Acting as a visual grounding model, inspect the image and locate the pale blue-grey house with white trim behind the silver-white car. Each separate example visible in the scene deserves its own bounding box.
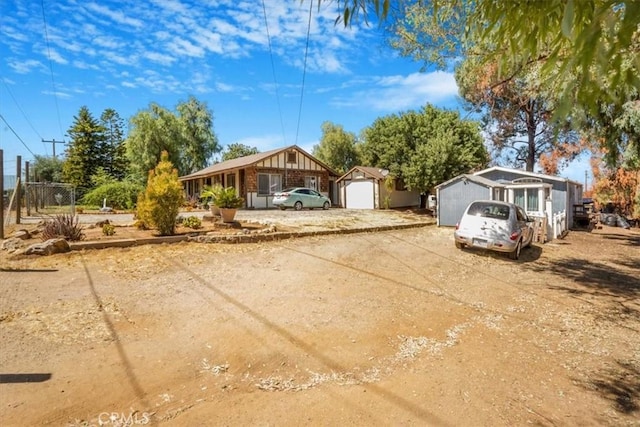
[436,166,582,240]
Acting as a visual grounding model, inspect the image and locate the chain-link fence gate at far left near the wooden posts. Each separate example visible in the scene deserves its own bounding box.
[24,182,76,216]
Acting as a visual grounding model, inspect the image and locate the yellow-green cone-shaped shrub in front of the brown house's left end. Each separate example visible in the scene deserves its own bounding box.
[136,151,184,236]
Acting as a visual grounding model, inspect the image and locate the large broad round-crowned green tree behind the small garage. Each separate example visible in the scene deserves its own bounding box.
[362,105,488,194]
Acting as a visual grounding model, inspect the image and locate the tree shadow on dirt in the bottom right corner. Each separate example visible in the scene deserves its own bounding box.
[578,360,640,415]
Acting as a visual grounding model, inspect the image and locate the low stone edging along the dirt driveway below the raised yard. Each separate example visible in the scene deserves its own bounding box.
[69,222,435,251]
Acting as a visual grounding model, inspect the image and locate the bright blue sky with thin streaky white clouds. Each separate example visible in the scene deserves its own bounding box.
[0,0,585,182]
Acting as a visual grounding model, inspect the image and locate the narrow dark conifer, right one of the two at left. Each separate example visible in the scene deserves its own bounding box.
[100,108,129,181]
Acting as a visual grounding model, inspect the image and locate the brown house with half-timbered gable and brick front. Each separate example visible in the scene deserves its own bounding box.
[179,145,338,209]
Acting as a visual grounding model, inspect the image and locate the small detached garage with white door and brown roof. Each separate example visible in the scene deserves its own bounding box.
[337,166,420,209]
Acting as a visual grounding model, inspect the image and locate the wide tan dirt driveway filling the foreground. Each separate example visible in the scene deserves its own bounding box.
[0,216,640,426]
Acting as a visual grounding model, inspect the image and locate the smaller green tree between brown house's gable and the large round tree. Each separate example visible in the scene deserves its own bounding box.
[312,121,360,173]
